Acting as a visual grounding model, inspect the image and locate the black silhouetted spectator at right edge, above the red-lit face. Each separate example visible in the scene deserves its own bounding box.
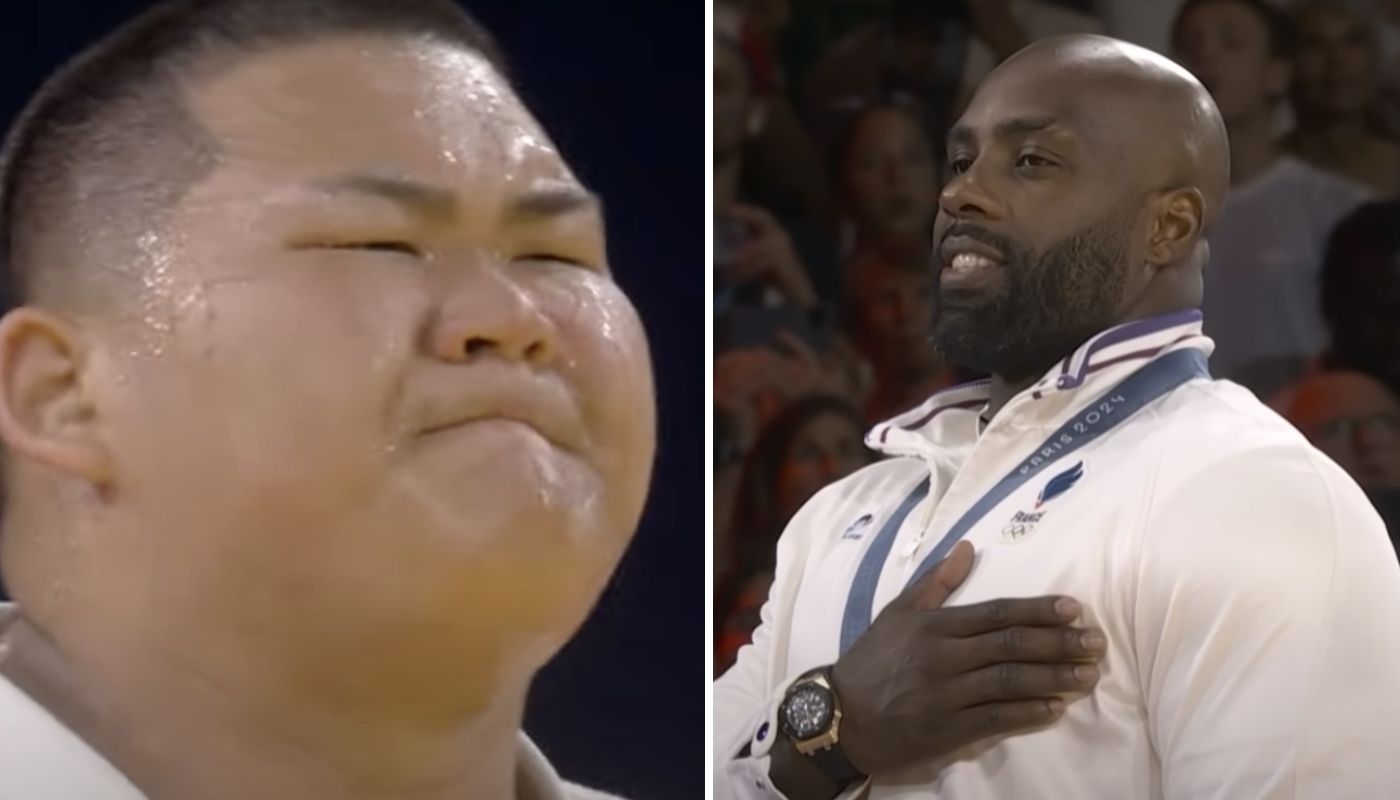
[1322,200,1400,396]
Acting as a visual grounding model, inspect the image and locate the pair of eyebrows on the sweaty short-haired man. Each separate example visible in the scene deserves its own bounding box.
[314,172,602,223]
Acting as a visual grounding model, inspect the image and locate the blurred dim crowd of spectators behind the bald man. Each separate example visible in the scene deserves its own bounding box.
[713,0,1400,674]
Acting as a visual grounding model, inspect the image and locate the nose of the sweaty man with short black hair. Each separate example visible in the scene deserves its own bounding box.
[428,268,557,366]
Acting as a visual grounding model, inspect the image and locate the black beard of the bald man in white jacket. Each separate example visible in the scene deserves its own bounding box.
[932,210,1131,382]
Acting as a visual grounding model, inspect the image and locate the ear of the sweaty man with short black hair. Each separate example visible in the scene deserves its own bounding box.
[0,308,112,486]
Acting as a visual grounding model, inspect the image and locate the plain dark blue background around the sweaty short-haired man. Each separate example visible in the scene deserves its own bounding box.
[0,0,708,800]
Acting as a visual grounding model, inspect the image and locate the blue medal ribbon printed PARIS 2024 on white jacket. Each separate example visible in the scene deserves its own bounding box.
[840,347,1210,654]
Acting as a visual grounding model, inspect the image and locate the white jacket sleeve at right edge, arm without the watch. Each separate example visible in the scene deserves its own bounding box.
[1131,444,1400,800]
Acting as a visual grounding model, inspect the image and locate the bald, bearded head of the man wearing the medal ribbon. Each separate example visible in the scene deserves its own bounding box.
[934,36,1229,381]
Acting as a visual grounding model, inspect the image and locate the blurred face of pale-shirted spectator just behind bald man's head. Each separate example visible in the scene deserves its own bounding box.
[1173,0,1289,125]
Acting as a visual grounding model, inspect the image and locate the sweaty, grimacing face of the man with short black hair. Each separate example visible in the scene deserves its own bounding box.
[80,38,655,683]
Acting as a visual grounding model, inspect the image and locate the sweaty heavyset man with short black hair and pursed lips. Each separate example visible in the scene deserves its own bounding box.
[0,0,652,800]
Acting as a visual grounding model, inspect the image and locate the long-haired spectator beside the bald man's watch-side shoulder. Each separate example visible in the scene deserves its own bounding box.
[714,395,872,674]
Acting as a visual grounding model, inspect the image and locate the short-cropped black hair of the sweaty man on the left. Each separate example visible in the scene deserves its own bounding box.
[0,0,508,318]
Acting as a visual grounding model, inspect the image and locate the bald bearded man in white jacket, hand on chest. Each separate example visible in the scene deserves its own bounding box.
[714,36,1400,800]
